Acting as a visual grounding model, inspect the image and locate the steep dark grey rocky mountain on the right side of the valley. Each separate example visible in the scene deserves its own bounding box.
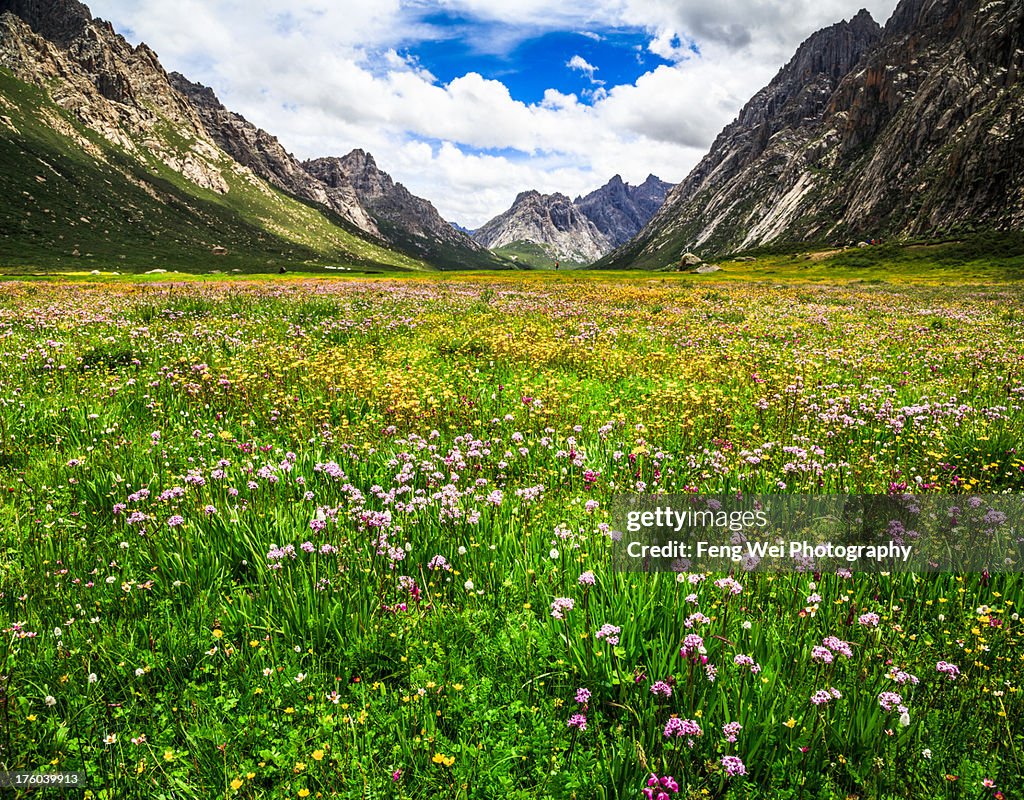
[597,0,1024,267]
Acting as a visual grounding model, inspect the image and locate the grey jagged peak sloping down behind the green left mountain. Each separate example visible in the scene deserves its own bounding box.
[302,150,508,269]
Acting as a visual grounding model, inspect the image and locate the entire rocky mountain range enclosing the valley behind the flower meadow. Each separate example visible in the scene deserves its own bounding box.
[0,0,1024,271]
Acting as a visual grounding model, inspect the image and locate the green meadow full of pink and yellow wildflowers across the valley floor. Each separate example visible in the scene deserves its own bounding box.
[0,275,1024,800]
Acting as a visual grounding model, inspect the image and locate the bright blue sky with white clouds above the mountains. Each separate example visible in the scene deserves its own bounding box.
[89,0,896,227]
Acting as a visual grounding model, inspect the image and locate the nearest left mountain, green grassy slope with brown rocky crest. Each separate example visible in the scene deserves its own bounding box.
[0,0,428,271]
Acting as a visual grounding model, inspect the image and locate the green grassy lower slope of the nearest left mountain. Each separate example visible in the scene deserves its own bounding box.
[0,69,428,272]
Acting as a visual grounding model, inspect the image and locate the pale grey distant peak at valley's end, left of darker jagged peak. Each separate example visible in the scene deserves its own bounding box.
[473,192,611,265]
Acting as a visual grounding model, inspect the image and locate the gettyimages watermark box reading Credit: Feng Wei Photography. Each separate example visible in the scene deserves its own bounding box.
[611,495,1024,573]
